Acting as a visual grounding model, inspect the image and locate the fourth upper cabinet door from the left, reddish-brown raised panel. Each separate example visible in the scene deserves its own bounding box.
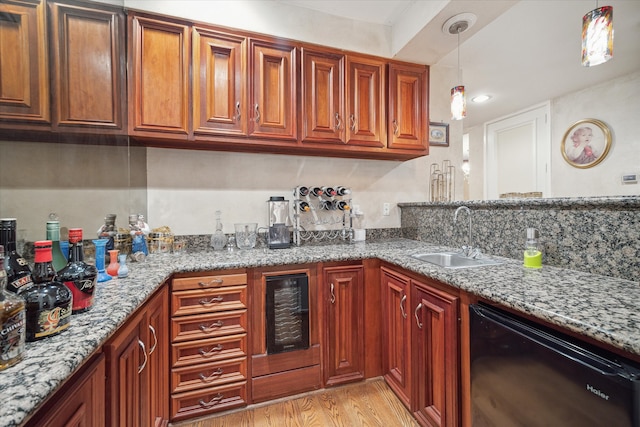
[193,27,248,136]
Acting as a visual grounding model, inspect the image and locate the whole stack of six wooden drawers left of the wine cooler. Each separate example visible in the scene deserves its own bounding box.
[167,270,250,421]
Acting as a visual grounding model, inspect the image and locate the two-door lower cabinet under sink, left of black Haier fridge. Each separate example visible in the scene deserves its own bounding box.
[381,267,460,427]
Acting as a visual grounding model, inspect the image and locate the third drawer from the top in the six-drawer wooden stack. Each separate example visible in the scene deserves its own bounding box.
[171,310,247,342]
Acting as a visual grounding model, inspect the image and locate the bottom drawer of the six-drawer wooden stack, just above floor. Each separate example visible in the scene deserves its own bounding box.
[171,381,247,421]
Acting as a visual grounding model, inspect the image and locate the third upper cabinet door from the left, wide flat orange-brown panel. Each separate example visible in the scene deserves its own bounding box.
[129,14,191,140]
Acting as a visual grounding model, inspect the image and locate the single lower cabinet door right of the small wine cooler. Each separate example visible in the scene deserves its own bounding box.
[323,266,365,386]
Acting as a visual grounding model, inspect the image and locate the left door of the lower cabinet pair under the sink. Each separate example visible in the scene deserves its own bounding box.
[381,267,411,408]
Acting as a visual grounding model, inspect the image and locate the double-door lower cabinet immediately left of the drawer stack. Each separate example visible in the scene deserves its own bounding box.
[104,286,169,427]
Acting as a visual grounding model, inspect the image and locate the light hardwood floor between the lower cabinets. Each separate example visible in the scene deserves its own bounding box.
[172,378,418,427]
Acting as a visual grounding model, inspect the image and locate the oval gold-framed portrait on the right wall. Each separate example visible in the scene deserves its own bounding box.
[560,119,611,169]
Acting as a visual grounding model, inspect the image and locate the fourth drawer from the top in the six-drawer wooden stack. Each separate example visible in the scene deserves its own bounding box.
[171,334,247,368]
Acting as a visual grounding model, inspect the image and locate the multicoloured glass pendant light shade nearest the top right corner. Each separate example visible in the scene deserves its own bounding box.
[582,2,613,67]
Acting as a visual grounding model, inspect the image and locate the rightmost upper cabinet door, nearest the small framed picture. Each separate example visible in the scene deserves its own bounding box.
[388,63,429,150]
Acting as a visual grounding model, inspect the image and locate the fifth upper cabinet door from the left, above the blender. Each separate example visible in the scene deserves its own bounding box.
[249,39,298,141]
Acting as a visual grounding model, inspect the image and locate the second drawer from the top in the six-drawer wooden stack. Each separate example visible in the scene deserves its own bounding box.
[171,285,247,316]
